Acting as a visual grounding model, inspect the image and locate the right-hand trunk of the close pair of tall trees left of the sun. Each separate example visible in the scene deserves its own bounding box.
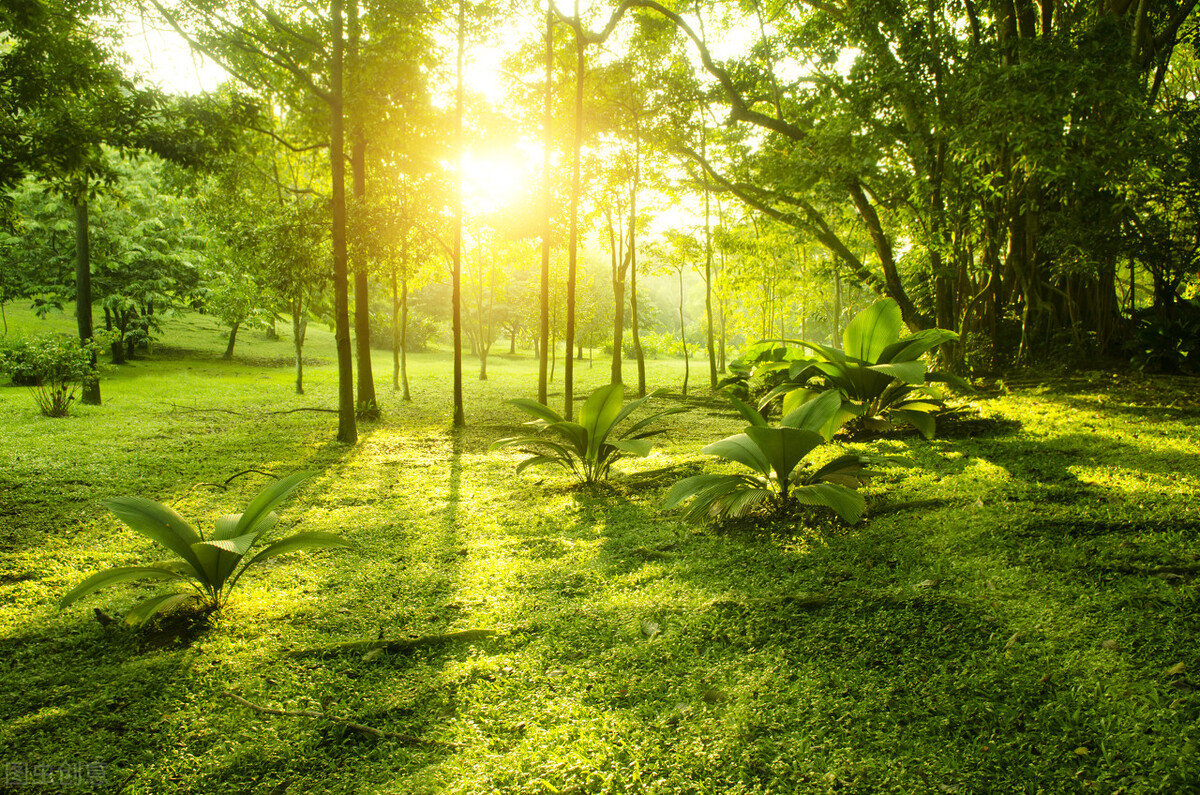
[346,0,379,417]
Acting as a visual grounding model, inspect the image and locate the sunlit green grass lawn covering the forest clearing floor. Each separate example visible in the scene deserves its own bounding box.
[0,310,1200,794]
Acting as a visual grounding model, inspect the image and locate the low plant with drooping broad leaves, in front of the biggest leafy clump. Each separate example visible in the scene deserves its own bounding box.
[664,391,893,524]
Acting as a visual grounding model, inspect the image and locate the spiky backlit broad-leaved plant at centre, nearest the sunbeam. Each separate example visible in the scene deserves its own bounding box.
[491,384,686,483]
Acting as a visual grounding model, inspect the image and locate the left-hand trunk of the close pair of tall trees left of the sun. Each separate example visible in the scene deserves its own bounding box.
[329,0,359,444]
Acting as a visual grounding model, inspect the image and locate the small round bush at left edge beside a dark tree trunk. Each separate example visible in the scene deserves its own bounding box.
[0,334,102,417]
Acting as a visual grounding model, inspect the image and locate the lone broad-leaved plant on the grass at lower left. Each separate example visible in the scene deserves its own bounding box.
[59,472,353,624]
